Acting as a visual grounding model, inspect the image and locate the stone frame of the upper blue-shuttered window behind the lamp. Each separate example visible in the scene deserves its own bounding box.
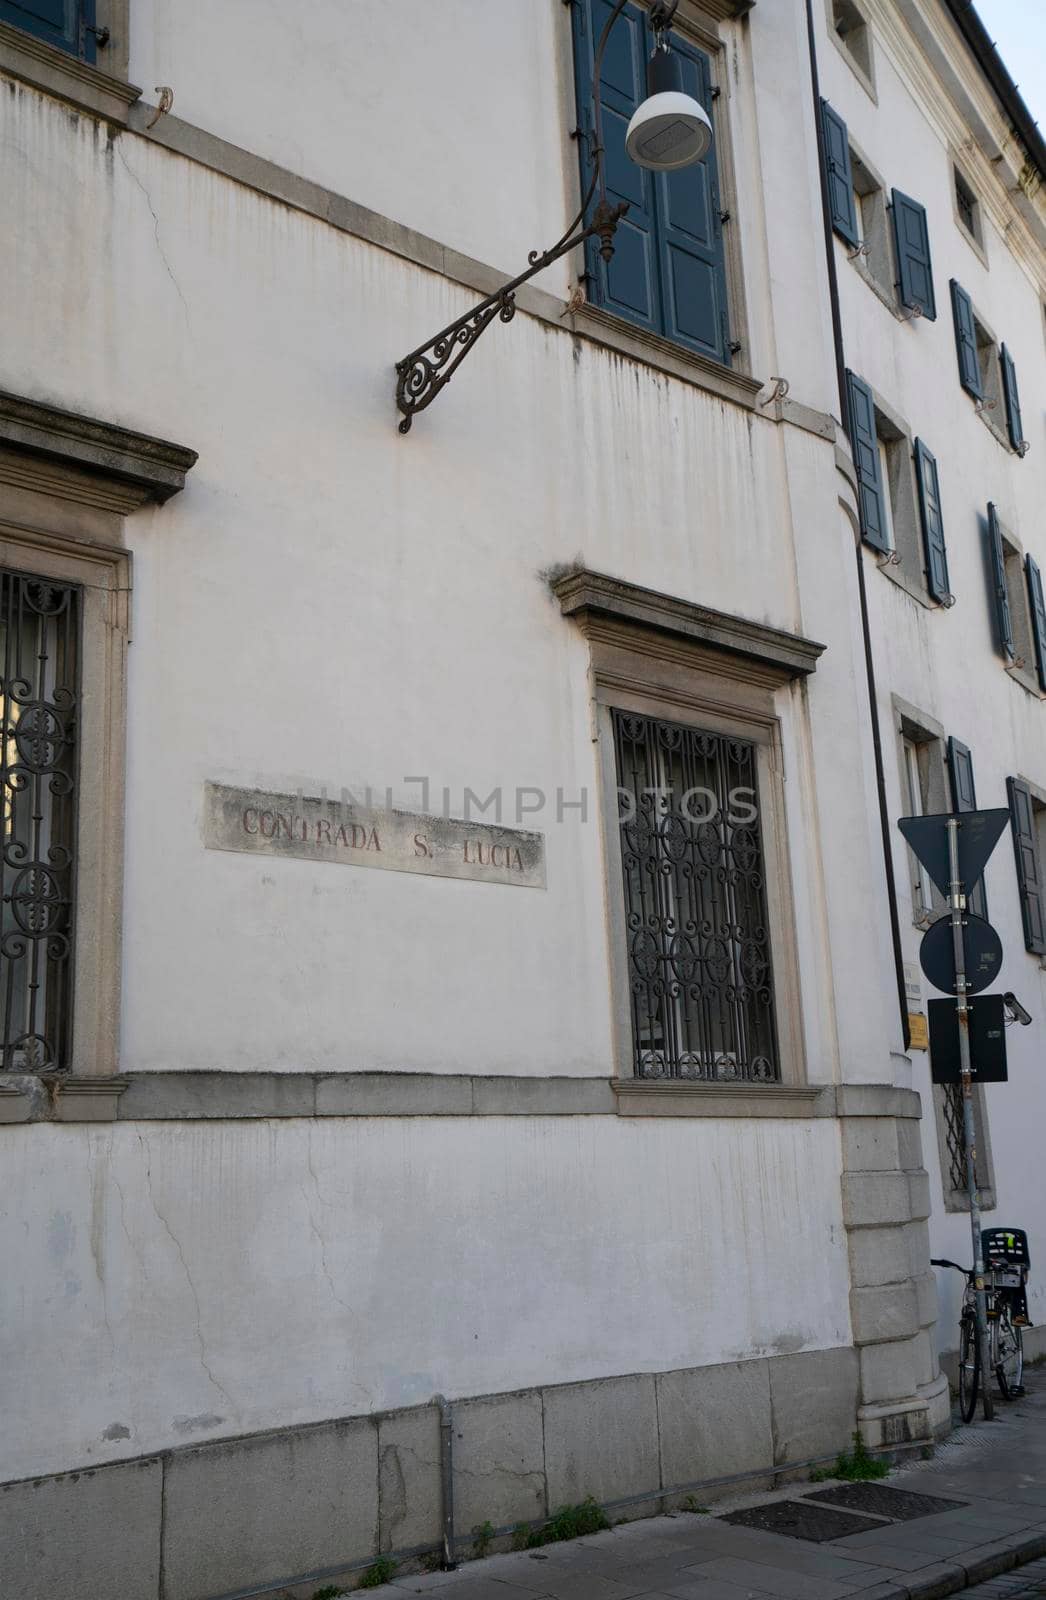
[566,0,761,396]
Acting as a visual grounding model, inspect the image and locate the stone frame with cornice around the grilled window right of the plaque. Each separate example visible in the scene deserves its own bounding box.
[552,568,824,1117]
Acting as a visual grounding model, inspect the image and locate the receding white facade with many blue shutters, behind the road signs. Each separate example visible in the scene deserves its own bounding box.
[819,0,1046,1376]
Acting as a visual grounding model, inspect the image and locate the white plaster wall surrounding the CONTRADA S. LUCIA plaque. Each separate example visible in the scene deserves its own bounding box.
[3,91,884,1080]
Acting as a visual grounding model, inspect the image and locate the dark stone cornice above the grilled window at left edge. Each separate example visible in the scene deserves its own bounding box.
[0,390,197,512]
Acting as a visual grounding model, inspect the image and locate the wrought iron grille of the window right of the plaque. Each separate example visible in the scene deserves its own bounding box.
[614,710,781,1083]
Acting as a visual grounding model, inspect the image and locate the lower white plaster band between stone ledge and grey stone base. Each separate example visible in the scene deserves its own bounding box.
[0,1117,849,1478]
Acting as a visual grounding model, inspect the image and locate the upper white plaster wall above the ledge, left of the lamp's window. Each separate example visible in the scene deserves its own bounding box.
[130,0,579,291]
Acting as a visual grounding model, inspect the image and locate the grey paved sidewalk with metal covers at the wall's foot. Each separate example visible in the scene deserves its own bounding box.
[373,1368,1046,1600]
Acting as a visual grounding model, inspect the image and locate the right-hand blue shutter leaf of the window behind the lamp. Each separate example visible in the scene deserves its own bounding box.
[651,34,729,362]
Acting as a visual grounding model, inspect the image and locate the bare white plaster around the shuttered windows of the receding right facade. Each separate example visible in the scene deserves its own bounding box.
[814,6,1046,1324]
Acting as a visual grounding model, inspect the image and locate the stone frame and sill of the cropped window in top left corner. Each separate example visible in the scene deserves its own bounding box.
[0,0,142,126]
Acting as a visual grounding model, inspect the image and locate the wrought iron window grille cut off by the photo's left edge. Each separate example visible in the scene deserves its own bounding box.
[0,571,80,1072]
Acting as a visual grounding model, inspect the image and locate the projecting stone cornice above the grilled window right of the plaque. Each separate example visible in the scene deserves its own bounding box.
[552,568,825,683]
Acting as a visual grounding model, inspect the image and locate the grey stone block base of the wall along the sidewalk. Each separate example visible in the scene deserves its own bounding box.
[0,1347,859,1600]
